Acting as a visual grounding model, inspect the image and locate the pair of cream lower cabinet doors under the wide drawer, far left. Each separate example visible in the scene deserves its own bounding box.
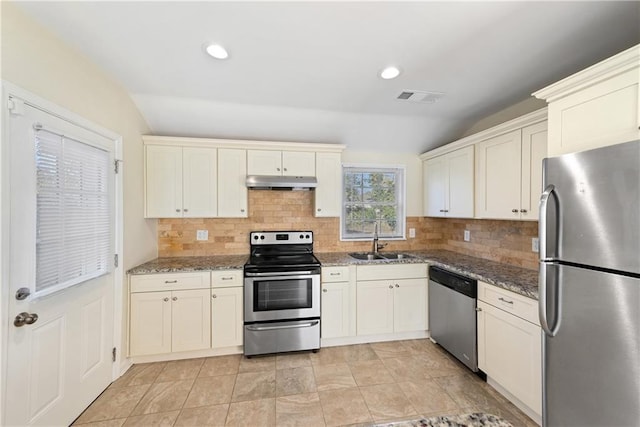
[130,289,211,356]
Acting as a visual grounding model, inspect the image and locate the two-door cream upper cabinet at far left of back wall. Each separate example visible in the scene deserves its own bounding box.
[145,145,218,218]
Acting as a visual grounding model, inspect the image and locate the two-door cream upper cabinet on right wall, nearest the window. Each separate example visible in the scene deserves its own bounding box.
[423,146,474,218]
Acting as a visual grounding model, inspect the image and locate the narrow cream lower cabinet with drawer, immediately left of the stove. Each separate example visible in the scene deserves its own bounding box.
[211,270,244,348]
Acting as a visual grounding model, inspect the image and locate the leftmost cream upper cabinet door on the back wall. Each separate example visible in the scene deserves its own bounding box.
[144,145,182,218]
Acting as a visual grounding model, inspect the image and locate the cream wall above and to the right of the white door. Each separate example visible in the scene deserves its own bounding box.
[1,1,157,374]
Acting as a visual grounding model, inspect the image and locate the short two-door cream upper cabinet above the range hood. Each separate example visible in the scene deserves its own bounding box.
[247,150,316,176]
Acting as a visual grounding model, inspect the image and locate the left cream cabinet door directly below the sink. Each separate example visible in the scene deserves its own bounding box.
[356,280,393,335]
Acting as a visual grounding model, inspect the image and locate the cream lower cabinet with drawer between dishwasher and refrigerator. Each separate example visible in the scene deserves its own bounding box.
[478,282,542,419]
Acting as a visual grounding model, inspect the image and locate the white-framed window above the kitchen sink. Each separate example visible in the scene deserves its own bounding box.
[341,165,405,240]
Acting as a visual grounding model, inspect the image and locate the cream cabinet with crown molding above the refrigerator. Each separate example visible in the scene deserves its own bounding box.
[534,45,640,156]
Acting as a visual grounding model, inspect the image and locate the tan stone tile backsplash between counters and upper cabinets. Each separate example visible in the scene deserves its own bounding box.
[158,190,538,269]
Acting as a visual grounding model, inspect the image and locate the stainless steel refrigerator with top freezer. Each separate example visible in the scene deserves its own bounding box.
[539,141,640,427]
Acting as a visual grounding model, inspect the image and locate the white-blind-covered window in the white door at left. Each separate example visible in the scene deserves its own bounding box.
[35,128,114,295]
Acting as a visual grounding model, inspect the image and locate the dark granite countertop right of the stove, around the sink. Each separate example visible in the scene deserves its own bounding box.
[315,250,538,299]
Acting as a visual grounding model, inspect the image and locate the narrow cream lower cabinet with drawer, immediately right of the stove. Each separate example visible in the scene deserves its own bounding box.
[320,266,356,338]
